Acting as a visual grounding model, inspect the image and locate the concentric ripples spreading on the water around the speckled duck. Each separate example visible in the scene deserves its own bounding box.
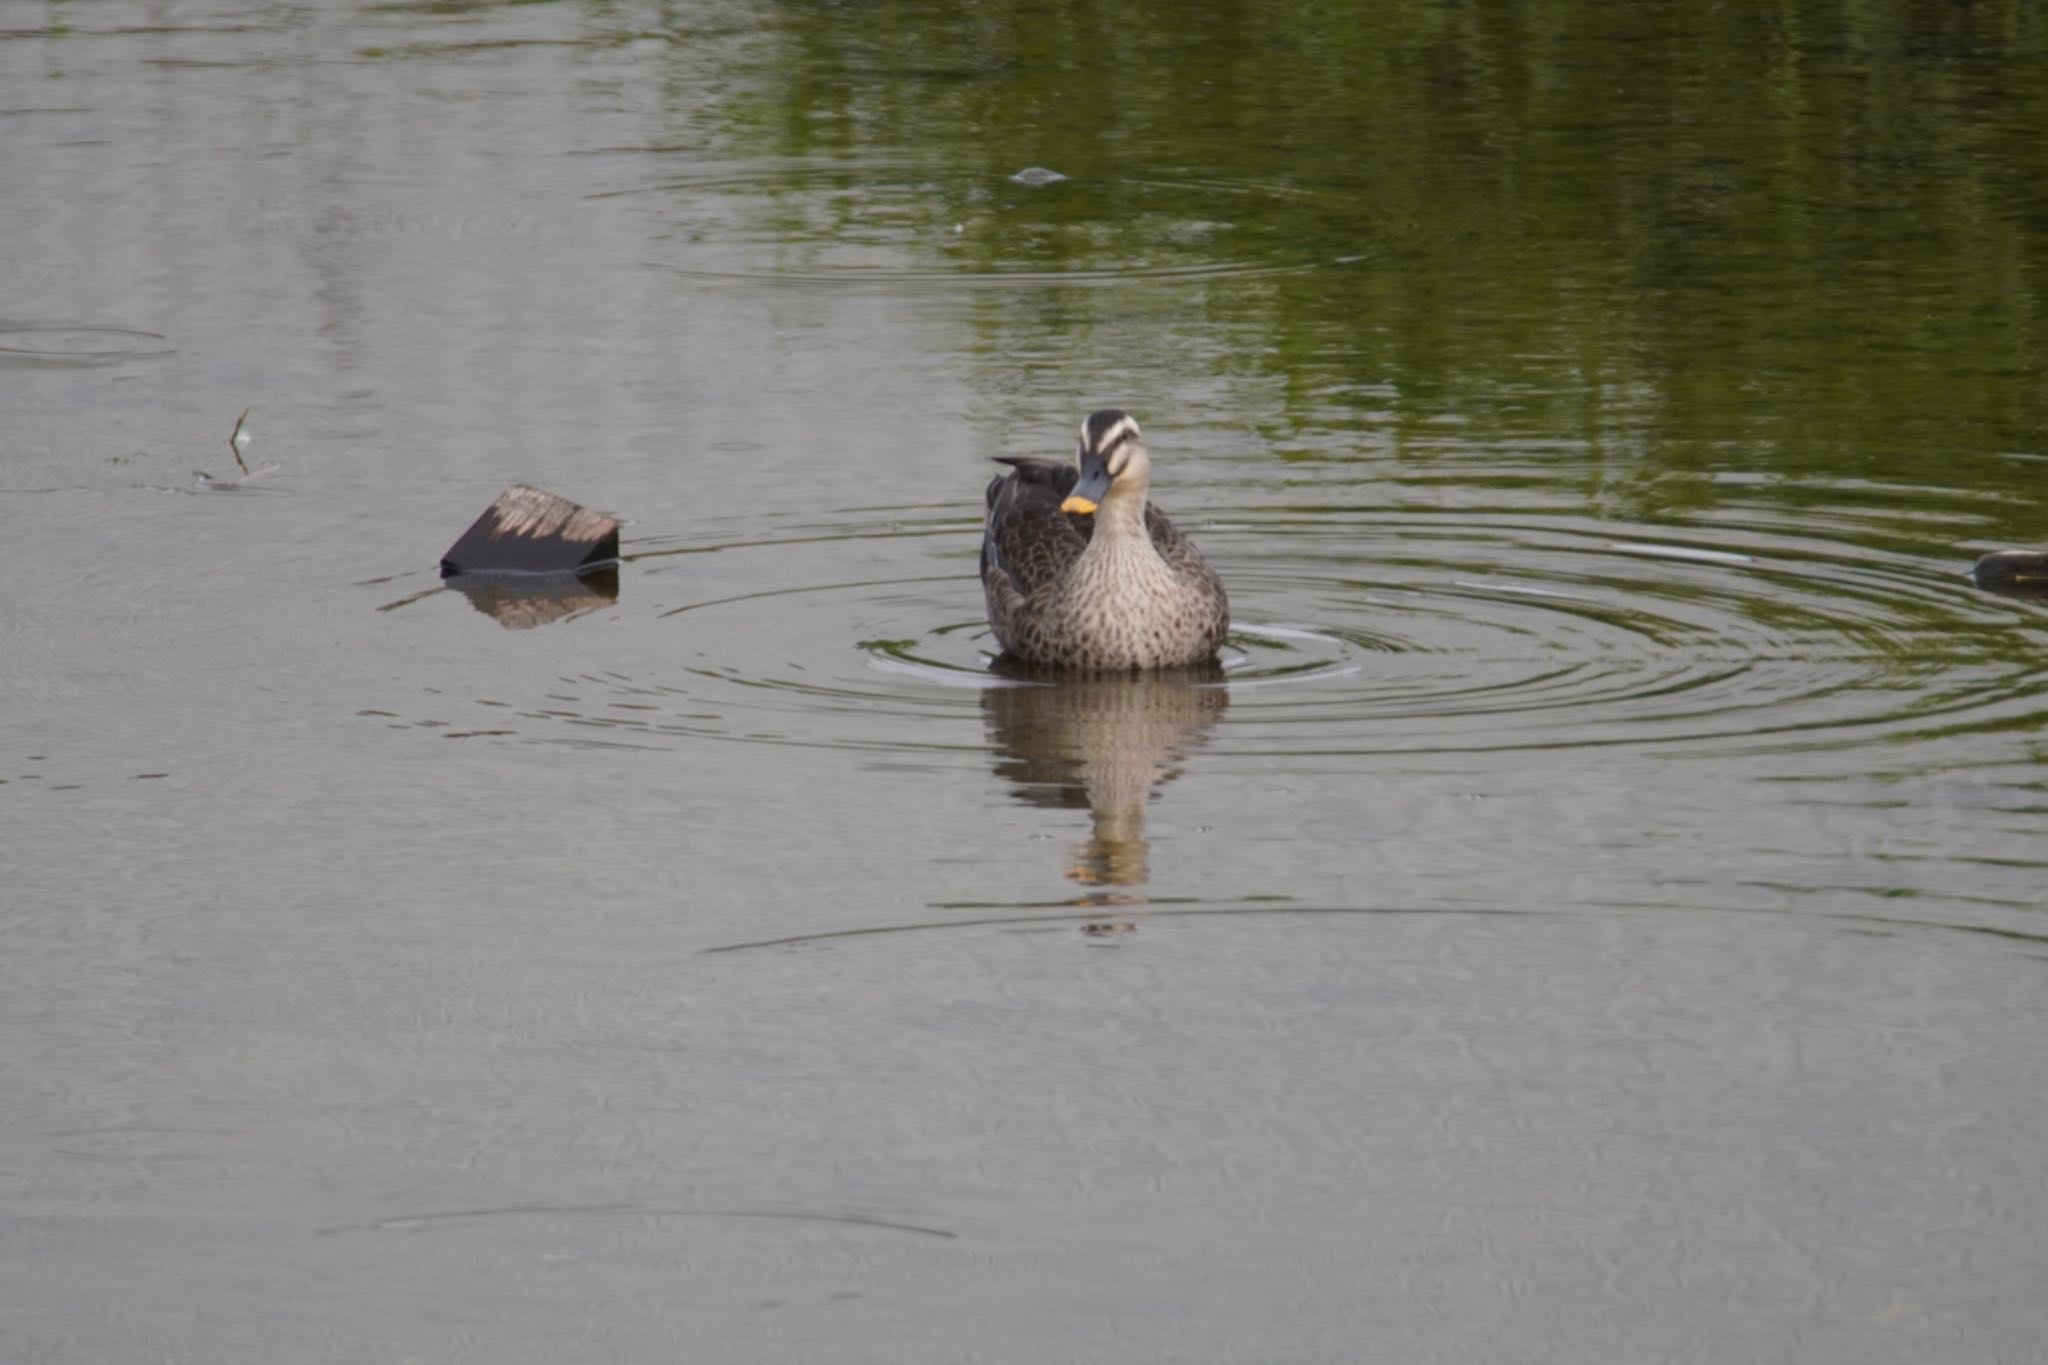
[376,512,2048,763]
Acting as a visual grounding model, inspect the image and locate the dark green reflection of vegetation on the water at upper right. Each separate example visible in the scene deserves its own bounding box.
[692,0,2048,509]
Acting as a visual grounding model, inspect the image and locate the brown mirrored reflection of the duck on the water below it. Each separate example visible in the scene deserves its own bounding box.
[981,665,1231,905]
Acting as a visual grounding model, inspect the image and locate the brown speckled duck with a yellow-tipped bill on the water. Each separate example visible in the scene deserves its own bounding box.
[981,407,1231,673]
